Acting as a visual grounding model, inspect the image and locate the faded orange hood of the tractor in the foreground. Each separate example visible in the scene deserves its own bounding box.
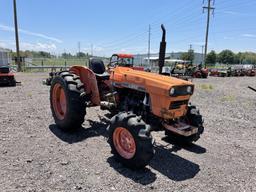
[110,67,194,95]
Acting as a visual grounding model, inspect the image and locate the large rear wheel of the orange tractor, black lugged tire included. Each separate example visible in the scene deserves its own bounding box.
[50,72,86,131]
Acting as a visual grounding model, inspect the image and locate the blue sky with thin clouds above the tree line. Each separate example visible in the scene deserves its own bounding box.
[0,0,256,56]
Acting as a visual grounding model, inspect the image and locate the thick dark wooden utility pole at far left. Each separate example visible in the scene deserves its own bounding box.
[13,0,21,72]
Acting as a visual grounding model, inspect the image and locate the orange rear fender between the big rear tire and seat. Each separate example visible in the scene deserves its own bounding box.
[69,66,100,105]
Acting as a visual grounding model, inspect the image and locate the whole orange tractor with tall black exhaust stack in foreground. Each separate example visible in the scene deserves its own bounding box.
[50,26,204,169]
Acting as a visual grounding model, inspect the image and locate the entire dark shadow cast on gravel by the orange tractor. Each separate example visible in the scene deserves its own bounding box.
[49,121,202,185]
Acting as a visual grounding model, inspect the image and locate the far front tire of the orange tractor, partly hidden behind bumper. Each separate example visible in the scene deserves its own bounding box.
[165,106,204,144]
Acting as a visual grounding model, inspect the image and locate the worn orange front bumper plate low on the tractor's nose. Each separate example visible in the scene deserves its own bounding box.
[163,123,198,137]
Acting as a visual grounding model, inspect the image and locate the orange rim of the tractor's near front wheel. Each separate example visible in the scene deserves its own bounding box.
[113,127,136,159]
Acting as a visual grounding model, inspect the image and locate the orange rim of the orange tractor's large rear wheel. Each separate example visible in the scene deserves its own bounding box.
[52,83,67,120]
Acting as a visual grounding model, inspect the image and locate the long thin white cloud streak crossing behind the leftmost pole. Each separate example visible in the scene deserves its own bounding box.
[0,24,62,43]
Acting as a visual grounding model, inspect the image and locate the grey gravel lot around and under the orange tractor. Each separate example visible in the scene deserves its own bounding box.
[0,73,256,192]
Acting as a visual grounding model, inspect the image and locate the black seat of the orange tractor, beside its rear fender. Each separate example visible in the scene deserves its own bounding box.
[89,58,110,80]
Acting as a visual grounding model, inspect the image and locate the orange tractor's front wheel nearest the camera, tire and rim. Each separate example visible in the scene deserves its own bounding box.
[108,112,155,169]
